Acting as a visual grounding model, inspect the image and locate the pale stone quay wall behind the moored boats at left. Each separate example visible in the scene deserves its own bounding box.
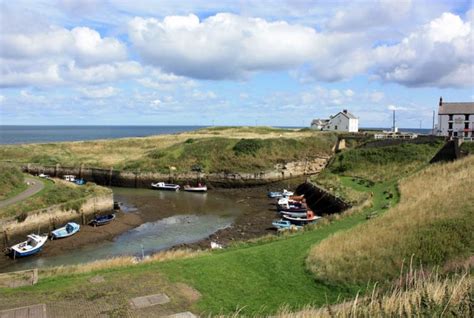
[0,191,114,244]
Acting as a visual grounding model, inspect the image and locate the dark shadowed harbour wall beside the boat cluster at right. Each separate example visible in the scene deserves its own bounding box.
[296,182,351,215]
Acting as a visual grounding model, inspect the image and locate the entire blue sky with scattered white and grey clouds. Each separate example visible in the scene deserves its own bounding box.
[0,0,474,128]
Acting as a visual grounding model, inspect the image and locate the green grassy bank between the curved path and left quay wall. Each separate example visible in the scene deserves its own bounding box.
[0,179,111,222]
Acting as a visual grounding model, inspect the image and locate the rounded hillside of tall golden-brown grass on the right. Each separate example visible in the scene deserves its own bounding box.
[307,156,474,284]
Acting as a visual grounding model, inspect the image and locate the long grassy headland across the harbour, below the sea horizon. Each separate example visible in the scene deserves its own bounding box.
[0,127,336,173]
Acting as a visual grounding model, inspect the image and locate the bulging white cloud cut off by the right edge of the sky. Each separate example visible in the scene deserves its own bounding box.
[374,13,474,87]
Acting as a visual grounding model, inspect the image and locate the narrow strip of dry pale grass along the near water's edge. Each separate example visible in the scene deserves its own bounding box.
[39,249,208,278]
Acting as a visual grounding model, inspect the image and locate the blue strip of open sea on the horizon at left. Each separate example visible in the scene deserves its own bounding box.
[0,125,204,144]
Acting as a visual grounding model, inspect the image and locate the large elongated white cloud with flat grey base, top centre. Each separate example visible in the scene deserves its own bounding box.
[129,13,317,79]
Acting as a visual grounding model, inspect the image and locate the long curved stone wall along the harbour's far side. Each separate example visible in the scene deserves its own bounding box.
[21,156,330,188]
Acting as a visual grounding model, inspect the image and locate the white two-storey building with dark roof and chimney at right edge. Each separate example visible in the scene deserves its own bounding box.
[436,97,474,140]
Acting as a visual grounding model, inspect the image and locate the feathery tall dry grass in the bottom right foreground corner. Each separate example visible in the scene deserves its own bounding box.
[277,271,474,318]
